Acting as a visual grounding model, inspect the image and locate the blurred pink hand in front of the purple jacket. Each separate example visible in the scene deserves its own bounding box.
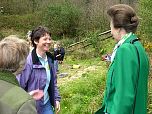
[29,89,44,100]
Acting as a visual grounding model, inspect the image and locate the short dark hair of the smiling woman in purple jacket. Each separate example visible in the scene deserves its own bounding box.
[30,26,51,48]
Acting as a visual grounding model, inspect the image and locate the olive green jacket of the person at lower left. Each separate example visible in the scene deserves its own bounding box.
[0,71,37,114]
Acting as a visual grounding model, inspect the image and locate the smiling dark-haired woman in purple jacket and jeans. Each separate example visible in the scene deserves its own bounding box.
[17,27,61,114]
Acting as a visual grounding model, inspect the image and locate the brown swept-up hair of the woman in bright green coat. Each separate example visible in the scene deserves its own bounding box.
[107,4,139,33]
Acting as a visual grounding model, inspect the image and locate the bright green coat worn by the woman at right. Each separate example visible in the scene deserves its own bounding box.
[95,35,149,114]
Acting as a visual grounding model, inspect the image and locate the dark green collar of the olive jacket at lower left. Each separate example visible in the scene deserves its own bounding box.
[0,71,19,86]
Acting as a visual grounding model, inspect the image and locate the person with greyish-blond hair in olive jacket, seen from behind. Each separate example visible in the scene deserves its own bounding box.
[0,35,37,114]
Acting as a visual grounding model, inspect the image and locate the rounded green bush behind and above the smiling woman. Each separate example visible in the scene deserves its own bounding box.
[43,2,81,36]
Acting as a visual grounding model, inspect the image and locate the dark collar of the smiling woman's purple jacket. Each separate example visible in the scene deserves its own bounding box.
[32,48,54,65]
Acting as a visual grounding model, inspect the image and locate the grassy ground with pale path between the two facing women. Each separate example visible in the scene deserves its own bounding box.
[58,57,152,114]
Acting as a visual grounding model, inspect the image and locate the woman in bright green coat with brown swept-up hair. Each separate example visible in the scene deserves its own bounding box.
[96,4,149,114]
